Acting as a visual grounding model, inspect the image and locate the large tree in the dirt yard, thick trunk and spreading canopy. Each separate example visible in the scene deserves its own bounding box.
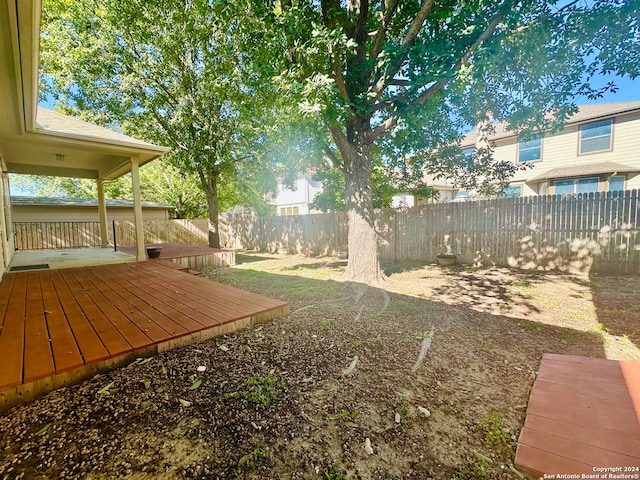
[242,0,640,282]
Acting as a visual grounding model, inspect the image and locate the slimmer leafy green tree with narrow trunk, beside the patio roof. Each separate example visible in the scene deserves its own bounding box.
[41,0,275,246]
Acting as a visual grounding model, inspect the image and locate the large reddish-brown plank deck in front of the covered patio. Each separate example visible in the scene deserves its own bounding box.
[0,261,288,410]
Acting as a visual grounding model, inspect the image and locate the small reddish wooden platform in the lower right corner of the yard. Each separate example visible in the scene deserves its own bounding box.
[516,354,640,478]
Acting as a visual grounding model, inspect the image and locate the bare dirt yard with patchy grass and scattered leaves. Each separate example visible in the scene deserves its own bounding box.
[0,254,640,480]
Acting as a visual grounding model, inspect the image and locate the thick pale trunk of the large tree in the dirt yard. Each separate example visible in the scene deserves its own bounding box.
[341,128,385,284]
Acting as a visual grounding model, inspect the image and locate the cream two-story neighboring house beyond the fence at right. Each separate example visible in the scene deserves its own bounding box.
[461,101,640,196]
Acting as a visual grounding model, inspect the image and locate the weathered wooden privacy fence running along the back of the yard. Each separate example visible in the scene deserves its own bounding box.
[11,190,640,273]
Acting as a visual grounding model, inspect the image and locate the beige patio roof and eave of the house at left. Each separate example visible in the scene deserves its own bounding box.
[0,0,169,180]
